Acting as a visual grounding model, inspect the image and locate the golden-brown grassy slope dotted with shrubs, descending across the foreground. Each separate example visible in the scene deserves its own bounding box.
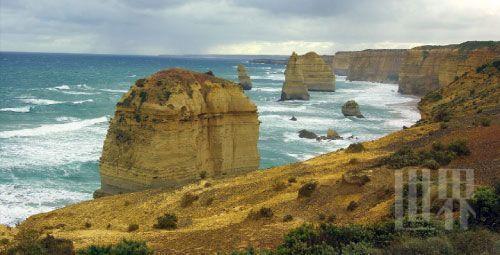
[8,62,500,254]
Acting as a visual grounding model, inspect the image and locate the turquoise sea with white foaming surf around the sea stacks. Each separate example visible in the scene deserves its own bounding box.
[0,52,420,224]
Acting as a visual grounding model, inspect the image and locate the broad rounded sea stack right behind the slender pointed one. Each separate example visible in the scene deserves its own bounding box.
[297,52,335,91]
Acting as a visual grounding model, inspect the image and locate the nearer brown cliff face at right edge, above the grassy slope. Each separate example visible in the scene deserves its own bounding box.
[399,42,500,95]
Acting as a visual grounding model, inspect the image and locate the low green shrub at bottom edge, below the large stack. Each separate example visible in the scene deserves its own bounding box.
[77,240,153,255]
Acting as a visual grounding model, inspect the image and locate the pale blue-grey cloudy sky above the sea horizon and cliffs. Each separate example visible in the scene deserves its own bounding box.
[0,0,500,55]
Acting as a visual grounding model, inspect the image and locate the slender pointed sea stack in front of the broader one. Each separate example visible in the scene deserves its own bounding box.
[281,52,309,101]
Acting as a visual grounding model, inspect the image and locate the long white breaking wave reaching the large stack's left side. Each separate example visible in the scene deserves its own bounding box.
[0,116,108,138]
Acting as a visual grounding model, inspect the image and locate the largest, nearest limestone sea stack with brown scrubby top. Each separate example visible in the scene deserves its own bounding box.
[94,68,259,197]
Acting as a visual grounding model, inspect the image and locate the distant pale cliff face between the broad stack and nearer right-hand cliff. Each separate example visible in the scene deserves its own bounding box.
[347,49,407,83]
